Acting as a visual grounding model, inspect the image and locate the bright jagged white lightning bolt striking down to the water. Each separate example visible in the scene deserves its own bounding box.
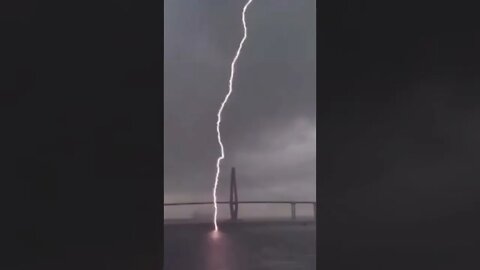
[213,0,252,231]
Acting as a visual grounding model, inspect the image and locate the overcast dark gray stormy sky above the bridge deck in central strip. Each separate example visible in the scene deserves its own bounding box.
[164,0,316,218]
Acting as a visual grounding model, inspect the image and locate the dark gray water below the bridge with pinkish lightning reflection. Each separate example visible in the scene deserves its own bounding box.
[163,223,316,270]
